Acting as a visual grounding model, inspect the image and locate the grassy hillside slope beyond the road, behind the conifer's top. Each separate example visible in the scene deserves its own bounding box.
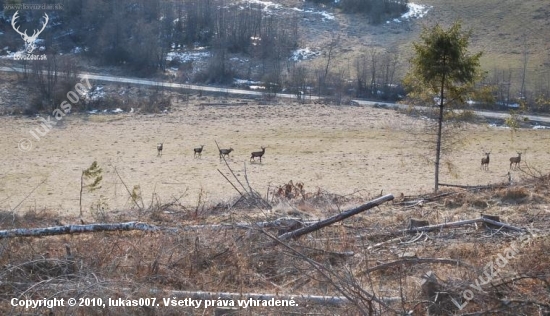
[301,0,550,84]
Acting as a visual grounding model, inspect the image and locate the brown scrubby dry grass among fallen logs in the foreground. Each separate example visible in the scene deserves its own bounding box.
[0,173,550,315]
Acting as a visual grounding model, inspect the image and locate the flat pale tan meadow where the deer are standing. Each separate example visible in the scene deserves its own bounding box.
[0,100,550,215]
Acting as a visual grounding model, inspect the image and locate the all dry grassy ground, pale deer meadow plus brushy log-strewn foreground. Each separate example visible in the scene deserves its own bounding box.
[0,96,550,315]
